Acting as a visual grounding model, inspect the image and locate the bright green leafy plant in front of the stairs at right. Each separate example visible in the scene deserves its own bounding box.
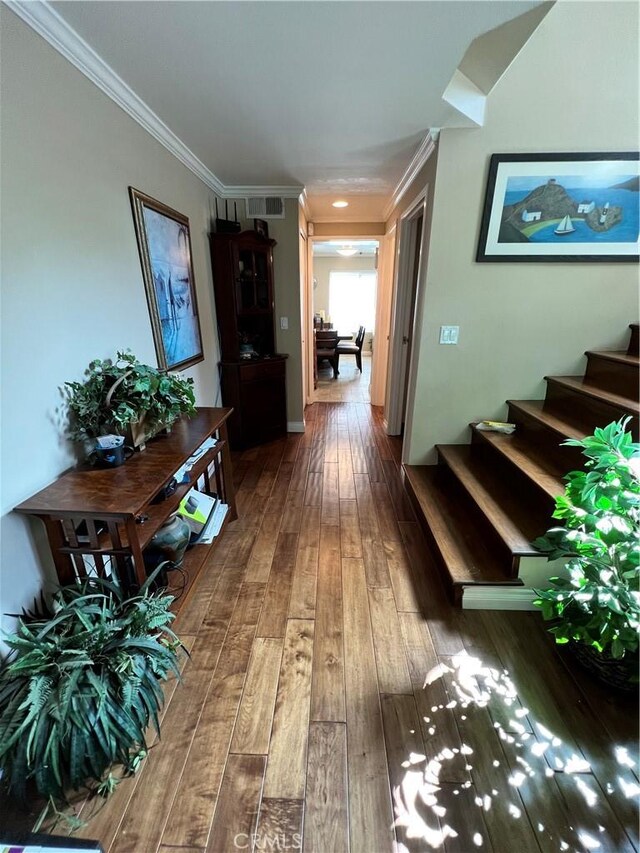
[533,418,640,659]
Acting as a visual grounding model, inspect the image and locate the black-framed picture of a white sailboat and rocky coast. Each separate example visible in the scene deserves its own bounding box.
[476,152,640,262]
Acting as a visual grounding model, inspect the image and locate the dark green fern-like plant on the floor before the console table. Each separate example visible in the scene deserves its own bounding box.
[0,576,181,798]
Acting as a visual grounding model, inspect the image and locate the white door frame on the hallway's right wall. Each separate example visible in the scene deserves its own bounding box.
[385,185,429,435]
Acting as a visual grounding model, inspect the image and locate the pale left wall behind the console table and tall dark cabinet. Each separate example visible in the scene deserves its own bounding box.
[0,5,302,644]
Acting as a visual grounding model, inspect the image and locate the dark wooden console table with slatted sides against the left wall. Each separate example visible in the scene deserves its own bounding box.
[15,408,238,590]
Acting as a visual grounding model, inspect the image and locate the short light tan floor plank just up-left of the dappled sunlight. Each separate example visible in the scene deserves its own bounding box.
[369,588,413,694]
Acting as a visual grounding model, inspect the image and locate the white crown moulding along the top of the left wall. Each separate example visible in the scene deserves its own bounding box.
[2,0,303,198]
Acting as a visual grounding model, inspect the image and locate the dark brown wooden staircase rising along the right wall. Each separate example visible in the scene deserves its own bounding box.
[403,323,640,603]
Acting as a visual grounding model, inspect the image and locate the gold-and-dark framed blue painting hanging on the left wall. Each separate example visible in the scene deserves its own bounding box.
[129,187,204,370]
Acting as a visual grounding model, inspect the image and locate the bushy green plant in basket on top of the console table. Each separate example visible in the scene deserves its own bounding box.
[65,352,196,441]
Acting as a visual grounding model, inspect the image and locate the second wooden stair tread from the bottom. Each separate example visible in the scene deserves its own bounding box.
[436,444,544,556]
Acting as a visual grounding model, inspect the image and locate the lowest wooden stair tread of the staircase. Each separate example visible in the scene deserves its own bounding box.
[403,465,522,586]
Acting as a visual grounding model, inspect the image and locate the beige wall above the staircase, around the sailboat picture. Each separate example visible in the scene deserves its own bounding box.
[396,2,639,464]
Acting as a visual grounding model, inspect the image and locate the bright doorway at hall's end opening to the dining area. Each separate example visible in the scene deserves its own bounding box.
[308,239,379,402]
